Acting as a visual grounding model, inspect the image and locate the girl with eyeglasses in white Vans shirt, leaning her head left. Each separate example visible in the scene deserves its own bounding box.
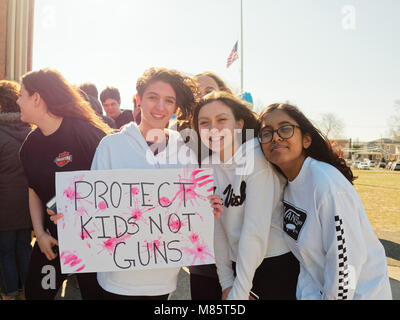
[258,104,392,300]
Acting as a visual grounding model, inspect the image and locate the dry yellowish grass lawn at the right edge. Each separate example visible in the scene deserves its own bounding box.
[353,169,400,232]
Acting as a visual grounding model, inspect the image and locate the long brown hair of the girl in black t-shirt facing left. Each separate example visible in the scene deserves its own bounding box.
[21,68,113,134]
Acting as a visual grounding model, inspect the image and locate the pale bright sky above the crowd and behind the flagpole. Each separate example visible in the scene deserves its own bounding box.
[33,0,400,141]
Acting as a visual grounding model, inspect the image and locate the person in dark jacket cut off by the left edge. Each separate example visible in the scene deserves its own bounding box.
[0,80,32,300]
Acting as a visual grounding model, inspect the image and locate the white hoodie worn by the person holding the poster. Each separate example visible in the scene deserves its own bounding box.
[91,122,198,296]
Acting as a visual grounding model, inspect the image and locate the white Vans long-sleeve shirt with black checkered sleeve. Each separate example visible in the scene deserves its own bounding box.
[283,157,392,299]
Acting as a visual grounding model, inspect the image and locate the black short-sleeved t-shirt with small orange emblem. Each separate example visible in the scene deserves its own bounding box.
[20,118,105,237]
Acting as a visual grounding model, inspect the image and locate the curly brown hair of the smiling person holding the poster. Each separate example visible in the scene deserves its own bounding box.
[136,67,199,131]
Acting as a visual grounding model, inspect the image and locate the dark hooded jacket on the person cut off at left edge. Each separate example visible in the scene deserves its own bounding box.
[0,113,32,231]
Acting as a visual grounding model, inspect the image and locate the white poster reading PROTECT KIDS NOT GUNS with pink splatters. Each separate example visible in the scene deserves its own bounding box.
[56,169,215,273]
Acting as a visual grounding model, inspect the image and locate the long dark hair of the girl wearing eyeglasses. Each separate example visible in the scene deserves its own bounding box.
[258,103,355,184]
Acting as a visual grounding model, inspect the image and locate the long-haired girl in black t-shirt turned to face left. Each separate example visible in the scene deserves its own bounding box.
[17,68,112,300]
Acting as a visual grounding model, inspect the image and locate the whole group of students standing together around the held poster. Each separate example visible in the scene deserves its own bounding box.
[0,68,392,300]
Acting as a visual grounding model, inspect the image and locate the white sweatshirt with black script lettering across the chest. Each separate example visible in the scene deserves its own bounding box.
[203,139,289,300]
